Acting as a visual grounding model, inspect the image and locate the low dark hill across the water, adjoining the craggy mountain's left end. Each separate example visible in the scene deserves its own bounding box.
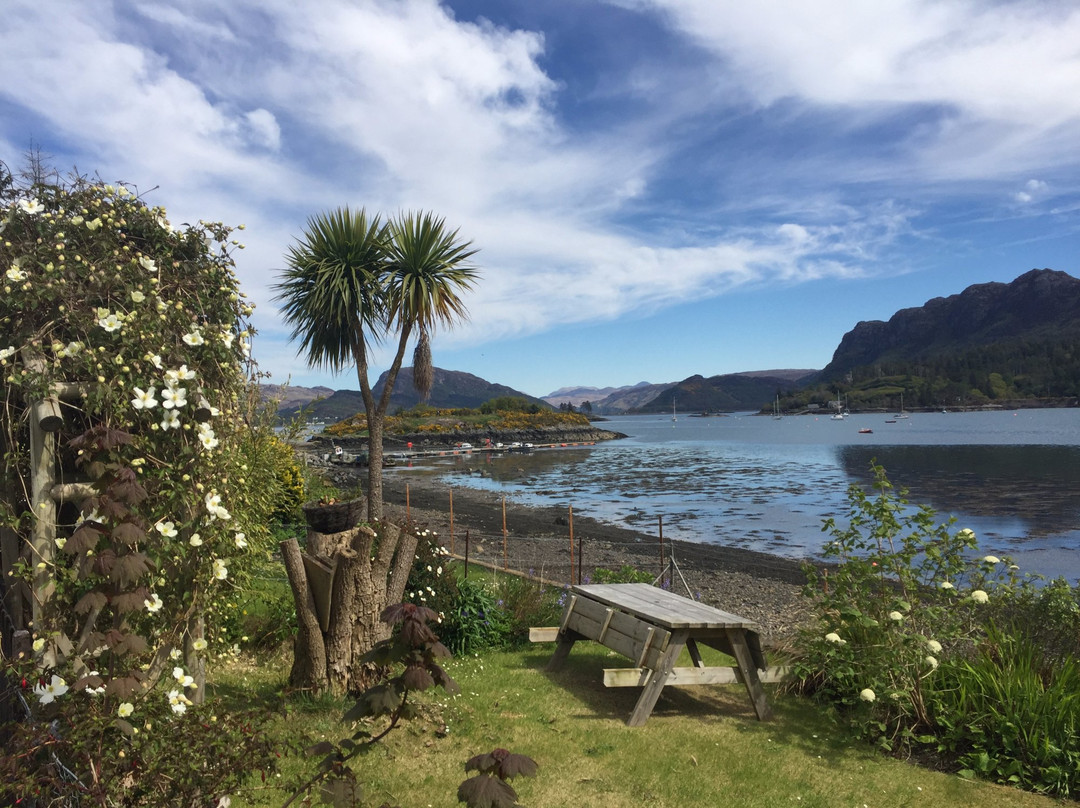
[638,371,815,413]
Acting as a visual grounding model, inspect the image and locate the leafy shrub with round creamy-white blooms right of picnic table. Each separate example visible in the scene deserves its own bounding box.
[796,464,1018,751]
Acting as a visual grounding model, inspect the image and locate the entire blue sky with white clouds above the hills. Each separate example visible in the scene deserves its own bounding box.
[0,0,1080,395]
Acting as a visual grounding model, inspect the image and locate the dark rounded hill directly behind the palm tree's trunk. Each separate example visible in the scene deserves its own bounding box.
[278,367,548,423]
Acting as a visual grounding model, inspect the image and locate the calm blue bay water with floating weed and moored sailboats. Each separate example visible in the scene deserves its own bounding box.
[403,409,1080,580]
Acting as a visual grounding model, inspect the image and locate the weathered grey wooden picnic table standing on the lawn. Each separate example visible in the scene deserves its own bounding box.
[540,583,780,727]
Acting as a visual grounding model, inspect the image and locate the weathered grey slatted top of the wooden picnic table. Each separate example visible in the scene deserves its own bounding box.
[570,583,760,633]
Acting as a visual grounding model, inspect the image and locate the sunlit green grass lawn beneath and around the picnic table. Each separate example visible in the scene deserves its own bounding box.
[213,643,1056,808]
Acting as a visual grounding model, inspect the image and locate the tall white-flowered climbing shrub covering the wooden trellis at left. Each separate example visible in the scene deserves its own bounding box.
[0,167,280,805]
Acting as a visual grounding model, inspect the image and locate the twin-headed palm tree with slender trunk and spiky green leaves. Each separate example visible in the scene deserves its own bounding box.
[275,207,476,520]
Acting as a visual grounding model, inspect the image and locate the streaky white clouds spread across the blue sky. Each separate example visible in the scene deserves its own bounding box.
[0,0,1080,388]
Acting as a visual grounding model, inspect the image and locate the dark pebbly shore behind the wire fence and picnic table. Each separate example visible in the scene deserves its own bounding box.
[319,467,809,645]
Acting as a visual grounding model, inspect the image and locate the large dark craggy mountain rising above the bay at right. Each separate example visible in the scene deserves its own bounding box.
[815,269,1080,406]
